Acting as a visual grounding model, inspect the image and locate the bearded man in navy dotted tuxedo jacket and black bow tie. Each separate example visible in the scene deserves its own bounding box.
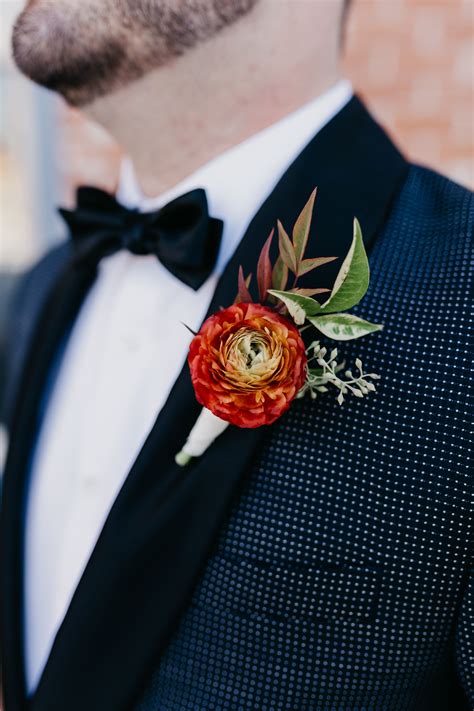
[2,0,474,711]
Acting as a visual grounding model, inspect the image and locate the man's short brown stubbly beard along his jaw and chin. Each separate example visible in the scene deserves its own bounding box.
[12,0,258,106]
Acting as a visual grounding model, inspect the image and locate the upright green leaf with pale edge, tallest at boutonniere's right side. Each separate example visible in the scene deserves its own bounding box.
[321,219,370,313]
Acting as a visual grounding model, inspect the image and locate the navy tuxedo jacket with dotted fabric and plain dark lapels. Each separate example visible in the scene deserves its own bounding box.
[1,98,474,711]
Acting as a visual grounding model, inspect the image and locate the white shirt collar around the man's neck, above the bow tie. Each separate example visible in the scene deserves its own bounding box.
[117,80,353,273]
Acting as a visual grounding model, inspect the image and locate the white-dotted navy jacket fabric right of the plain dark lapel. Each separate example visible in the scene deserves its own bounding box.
[135,167,474,711]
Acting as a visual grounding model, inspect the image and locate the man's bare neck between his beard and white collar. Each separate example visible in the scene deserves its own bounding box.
[87,4,340,196]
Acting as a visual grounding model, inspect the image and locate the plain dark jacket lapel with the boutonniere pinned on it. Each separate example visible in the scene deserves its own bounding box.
[1,98,407,711]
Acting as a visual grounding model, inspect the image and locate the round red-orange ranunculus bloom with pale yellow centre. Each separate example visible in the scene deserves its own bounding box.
[188,303,307,427]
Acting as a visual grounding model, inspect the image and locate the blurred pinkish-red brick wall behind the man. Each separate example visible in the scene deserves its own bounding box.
[61,0,474,203]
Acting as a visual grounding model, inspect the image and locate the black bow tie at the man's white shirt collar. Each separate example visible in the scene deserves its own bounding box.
[59,187,223,290]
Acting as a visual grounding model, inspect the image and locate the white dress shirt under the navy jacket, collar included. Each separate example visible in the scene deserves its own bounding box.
[24,81,352,693]
